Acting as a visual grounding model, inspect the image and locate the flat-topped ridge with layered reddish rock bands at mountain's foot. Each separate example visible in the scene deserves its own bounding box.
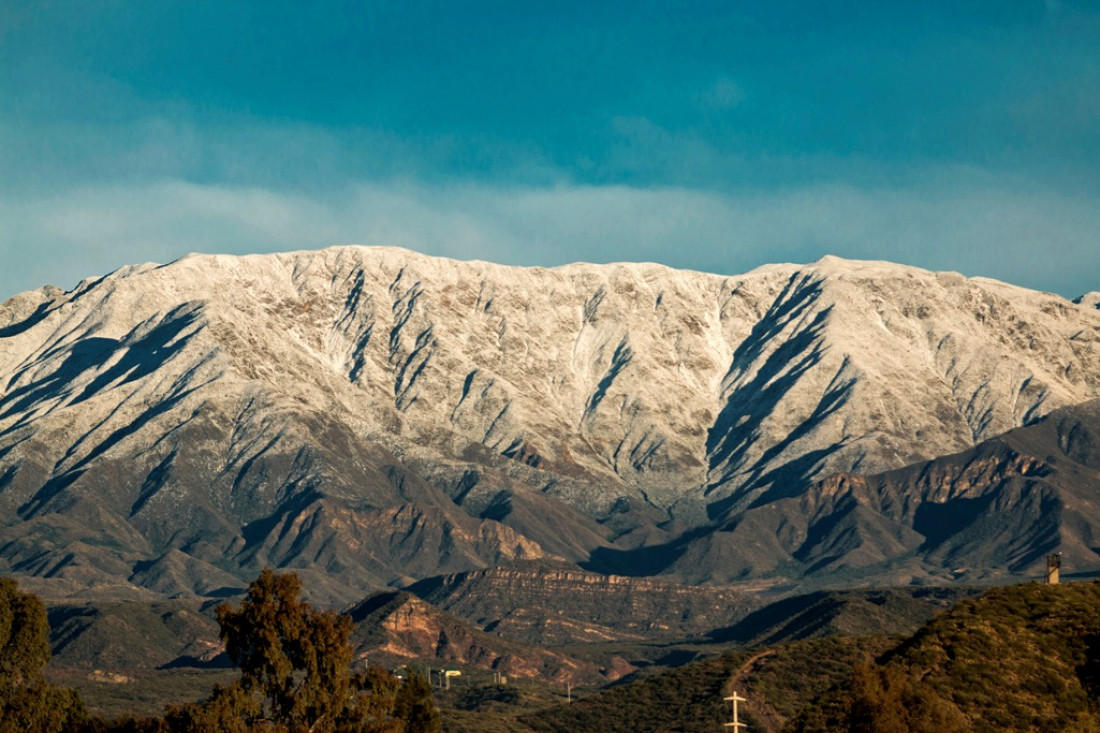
[406,561,743,645]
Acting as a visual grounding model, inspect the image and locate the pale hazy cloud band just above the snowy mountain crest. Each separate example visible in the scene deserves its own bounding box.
[0,176,1100,297]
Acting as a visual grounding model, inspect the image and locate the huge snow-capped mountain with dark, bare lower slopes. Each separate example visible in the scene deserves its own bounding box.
[0,247,1100,602]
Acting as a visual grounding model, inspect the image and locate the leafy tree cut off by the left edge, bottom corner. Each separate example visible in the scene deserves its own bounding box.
[0,578,87,733]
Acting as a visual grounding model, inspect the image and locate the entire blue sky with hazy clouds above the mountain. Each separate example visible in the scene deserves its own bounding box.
[0,0,1100,298]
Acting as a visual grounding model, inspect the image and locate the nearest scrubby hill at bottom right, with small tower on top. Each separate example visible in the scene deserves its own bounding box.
[791,582,1100,732]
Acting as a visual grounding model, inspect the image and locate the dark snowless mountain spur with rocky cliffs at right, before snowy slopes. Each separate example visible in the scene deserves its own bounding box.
[624,402,1100,586]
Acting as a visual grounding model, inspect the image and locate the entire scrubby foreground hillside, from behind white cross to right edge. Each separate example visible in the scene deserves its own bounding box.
[521,582,1100,733]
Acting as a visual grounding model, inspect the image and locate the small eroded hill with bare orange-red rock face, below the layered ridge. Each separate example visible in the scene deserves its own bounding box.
[348,592,634,685]
